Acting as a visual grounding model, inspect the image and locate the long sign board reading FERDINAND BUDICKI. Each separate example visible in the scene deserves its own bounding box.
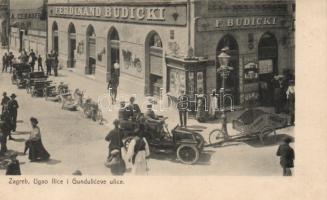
[49,5,186,25]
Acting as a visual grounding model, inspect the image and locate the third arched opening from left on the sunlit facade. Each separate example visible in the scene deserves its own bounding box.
[85,25,96,74]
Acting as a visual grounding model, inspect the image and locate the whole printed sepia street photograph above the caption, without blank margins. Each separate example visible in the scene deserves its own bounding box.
[0,0,295,176]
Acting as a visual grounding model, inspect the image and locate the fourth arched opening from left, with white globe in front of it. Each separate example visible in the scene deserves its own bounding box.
[107,27,120,80]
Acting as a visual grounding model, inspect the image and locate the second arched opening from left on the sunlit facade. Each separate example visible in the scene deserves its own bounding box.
[67,23,76,68]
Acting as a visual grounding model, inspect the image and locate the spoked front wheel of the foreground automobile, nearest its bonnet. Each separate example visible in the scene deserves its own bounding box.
[177,144,199,165]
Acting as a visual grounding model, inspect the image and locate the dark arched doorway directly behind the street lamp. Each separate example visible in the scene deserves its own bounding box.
[216,35,240,105]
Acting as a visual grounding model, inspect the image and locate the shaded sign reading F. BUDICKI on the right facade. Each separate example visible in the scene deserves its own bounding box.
[197,16,290,31]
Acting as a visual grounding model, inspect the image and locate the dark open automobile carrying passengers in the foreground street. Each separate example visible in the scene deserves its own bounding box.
[124,119,204,165]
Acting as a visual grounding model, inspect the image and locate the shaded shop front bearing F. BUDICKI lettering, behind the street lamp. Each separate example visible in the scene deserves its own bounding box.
[195,3,294,107]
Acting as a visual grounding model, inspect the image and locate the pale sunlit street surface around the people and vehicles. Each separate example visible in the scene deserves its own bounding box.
[0,49,294,176]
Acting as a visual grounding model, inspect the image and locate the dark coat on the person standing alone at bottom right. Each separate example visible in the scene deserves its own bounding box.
[277,144,295,168]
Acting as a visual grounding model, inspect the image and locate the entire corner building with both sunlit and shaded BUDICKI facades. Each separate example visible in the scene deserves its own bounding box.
[48,0,294,108]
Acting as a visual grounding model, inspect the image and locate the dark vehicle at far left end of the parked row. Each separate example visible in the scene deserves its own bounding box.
[11,63,31,88]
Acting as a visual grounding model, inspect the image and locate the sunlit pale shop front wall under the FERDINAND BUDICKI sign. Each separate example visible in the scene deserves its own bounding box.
[48,1,188,98]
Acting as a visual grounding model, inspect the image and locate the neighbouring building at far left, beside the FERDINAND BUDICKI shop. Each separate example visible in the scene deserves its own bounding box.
[10,0,47,57]
